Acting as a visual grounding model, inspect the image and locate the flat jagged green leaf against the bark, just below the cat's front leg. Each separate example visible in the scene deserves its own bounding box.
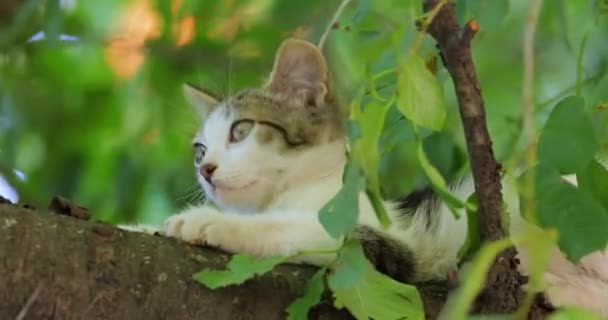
[194,254,289,289]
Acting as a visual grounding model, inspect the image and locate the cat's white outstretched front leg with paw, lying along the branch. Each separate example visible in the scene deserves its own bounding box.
[165,207,339,264]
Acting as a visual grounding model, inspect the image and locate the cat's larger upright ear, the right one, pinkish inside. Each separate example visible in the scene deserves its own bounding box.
[266,39,328,106]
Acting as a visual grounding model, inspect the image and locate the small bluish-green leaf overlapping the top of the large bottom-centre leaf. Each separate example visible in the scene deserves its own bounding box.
[328,239,368,289]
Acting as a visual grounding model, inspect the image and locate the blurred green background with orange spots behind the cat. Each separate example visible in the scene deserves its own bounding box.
[0,0,608,223]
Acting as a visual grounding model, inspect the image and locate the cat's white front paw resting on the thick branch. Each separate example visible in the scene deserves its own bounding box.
[164,207,229,245]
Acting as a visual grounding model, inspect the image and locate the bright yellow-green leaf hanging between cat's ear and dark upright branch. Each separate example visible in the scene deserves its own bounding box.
[397,54,446,131]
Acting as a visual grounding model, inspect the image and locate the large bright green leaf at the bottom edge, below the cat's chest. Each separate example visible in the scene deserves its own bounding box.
[328,249,424,320]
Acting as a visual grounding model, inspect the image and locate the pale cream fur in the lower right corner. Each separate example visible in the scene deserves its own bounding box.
[520,248,608,319]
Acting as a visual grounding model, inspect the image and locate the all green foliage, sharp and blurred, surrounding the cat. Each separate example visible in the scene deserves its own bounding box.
[0,0,608,319]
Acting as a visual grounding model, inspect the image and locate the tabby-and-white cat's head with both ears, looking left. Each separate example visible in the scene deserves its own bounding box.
[184,39,345,211]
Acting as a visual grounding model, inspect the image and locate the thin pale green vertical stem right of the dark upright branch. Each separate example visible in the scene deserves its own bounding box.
[521,0,543,219]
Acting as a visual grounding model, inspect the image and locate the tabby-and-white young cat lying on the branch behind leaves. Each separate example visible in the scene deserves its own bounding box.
[134,39,608,316]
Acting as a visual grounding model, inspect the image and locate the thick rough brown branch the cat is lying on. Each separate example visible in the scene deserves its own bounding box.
[0,204,446,320]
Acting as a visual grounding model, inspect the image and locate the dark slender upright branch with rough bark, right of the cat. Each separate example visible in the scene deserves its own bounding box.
[423,0,523,313]
